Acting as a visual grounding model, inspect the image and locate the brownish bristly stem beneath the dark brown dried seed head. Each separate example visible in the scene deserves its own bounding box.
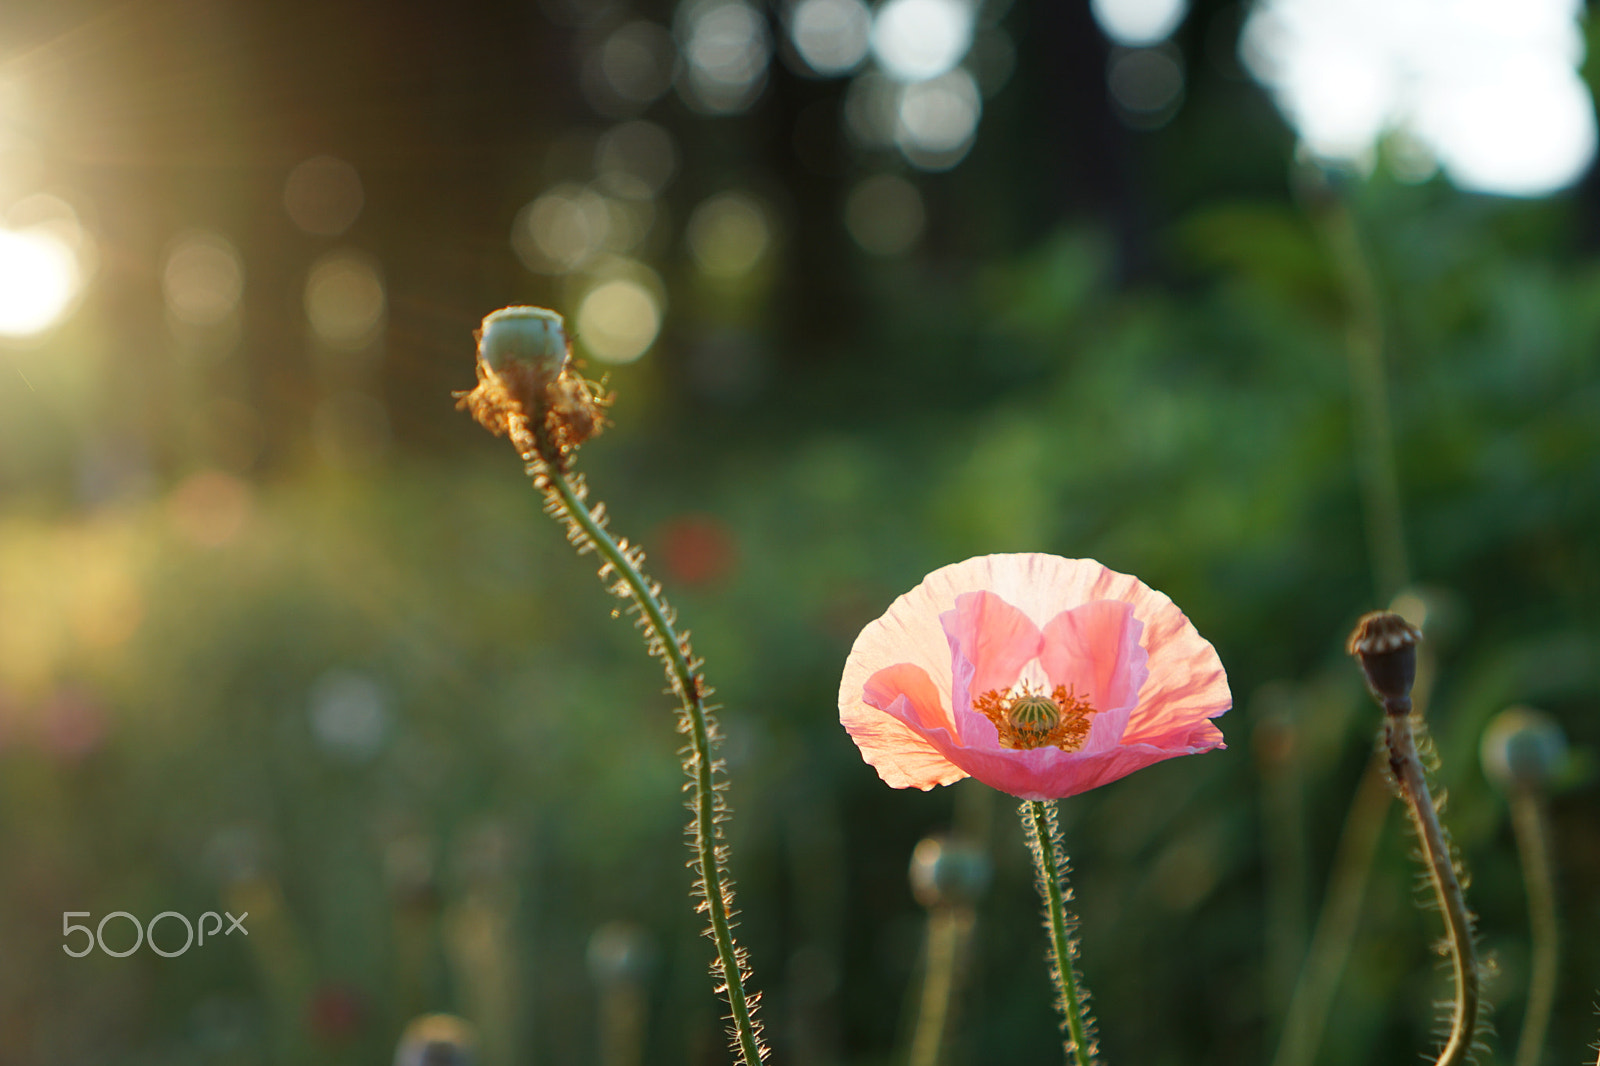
[1384,699,1480,1066]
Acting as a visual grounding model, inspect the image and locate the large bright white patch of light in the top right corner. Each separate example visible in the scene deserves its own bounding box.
[1240,0,1597,197]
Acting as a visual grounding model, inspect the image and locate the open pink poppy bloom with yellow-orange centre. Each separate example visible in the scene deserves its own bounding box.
[838,552,1234,800]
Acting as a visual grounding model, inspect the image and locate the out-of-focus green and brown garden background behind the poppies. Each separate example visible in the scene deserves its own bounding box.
[0,0,1600,1066]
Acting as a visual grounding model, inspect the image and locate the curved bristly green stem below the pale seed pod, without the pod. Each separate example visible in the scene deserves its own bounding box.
[544,459,766,1066]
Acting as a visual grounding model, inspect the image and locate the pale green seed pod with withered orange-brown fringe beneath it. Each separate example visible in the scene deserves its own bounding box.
[456,300,610,469]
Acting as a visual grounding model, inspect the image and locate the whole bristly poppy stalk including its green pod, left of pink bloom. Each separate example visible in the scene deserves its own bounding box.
[458,307,766,1066]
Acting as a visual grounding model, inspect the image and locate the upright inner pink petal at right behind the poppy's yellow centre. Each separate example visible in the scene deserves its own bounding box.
[1038,600,1150,751]
